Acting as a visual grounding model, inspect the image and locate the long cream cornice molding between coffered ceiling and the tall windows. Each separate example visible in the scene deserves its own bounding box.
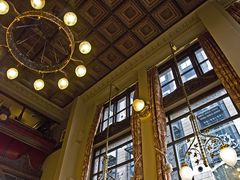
[81,12,205,103]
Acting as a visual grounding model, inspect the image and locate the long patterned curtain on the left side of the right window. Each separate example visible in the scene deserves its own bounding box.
[148,67,169,180]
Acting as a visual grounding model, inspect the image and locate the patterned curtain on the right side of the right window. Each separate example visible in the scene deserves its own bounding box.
[199,32,240,109]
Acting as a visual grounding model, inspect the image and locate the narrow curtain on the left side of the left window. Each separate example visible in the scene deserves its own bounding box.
[81,105,103,180]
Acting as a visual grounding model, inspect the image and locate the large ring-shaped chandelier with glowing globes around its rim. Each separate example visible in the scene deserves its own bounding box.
[0,0,91,91]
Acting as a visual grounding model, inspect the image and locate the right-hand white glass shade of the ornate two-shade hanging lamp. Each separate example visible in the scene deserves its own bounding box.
[220,144,237,167]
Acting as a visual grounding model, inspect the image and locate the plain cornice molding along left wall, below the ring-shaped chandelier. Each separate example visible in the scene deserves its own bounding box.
[0,74,68,122]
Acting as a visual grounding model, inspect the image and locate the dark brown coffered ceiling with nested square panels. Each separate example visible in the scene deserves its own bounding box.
[0,0,205,107]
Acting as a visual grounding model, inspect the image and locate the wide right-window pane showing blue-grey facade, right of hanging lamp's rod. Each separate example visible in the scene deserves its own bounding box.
[195,97,237,129]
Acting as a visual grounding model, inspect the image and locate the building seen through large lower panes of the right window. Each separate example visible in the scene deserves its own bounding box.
[167,88,240,180]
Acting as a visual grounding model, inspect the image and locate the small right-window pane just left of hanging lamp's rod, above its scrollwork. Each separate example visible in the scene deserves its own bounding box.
[172,117,193,140]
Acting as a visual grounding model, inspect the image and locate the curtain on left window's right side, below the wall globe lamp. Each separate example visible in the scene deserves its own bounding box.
[131,85,144,180]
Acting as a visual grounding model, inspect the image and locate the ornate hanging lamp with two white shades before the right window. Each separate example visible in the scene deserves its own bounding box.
[170,43,237,180]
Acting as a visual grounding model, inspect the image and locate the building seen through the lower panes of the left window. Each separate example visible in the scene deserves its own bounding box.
[93,135,134,180]
